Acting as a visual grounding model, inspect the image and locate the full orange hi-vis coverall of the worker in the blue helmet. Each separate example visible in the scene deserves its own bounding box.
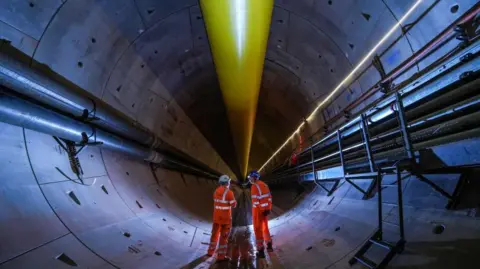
[250,180,272,251]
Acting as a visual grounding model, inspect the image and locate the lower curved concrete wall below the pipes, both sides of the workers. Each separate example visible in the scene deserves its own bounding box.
[0,121,480,269]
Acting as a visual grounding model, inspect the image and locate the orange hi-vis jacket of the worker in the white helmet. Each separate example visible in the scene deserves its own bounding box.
[213,186,237,224]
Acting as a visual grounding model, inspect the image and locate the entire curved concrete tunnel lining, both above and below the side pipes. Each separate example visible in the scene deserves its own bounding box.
[0,0,480,269]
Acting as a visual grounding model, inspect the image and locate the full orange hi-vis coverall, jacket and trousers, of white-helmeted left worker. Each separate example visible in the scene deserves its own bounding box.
[208,186,237,260]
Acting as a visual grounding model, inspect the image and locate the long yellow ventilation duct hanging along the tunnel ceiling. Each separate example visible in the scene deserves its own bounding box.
[200,0,273,176]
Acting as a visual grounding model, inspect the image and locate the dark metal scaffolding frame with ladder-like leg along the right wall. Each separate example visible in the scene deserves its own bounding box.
[311,92,465,268]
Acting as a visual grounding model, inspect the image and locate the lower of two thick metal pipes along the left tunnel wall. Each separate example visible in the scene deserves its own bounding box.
[0,91,163,163]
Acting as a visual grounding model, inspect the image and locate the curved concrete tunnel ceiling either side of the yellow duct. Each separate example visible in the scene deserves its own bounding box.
[0,0,476,175]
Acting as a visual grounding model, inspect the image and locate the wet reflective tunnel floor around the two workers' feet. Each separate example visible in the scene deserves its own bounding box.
[182,226,283,269]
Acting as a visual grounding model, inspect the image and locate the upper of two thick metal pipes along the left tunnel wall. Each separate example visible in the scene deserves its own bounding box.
[0,53,161,148]
